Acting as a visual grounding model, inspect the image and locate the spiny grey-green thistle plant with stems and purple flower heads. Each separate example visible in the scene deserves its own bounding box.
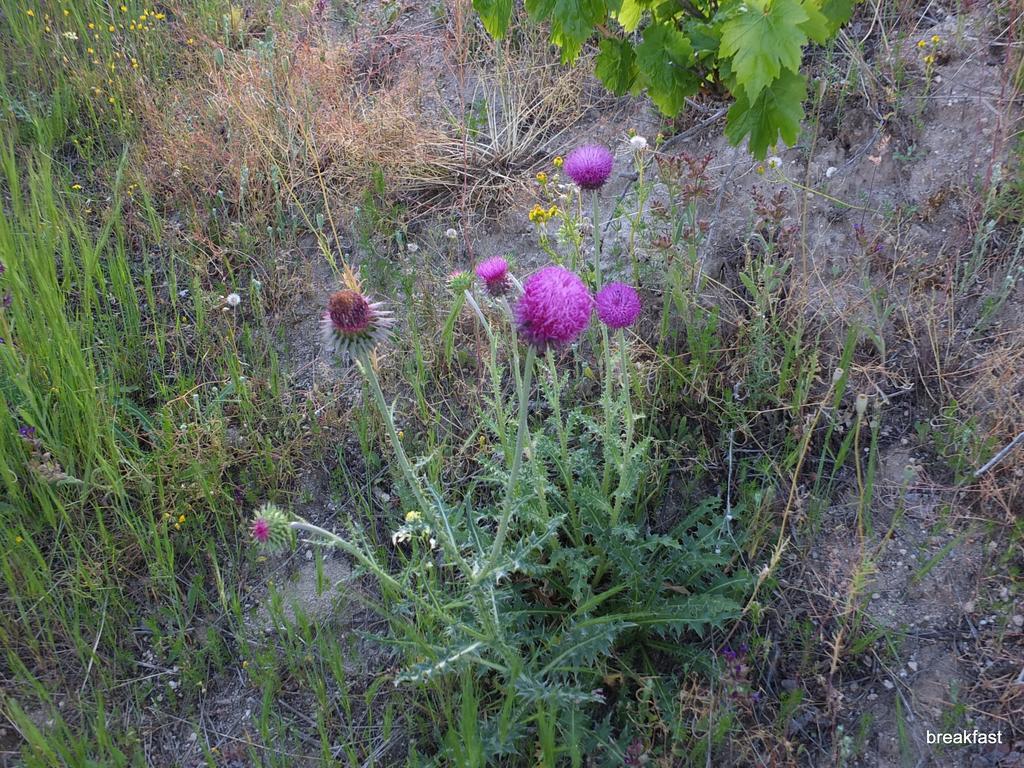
[251,188,743,760]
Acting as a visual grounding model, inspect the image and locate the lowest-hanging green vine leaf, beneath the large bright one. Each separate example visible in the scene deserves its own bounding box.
[725,72,807,159]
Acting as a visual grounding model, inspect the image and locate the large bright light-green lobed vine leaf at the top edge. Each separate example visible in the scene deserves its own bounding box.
[719,0,810,100]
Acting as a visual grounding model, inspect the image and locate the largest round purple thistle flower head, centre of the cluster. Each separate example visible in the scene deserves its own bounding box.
[515,266,594,349]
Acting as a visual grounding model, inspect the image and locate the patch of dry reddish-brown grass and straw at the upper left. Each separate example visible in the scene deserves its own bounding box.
[143,12,587,228]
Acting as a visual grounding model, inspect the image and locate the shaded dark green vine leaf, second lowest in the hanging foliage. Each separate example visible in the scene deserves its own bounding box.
[636,24,700,117]
